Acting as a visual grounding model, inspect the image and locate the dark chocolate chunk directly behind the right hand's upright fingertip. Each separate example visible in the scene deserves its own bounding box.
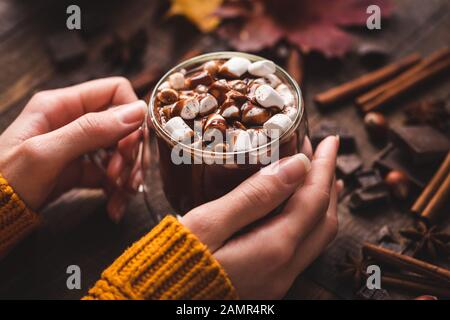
[311,121,356,153]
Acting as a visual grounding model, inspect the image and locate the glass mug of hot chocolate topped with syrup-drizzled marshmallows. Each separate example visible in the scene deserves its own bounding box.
[144,53,310,213]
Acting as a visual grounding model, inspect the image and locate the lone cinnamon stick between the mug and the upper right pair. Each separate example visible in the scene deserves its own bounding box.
[314,53,421,106]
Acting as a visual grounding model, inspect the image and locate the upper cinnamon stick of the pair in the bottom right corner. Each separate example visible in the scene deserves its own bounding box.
[363,242,450,286]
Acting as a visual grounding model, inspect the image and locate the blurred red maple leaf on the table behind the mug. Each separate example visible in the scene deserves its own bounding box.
[217,0,393,57]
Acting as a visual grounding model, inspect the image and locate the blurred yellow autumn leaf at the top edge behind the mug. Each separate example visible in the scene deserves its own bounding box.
[168,0,223,32]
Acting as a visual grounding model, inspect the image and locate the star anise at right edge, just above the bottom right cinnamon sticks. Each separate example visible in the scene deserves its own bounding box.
[399,221,450,260]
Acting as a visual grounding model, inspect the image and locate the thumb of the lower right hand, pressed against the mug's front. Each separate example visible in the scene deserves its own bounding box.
[181,153,311,251]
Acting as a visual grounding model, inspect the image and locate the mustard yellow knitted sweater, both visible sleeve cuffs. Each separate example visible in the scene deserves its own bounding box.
[0,175,237,300]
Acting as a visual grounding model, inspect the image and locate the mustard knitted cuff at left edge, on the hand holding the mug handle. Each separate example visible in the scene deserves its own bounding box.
[0,174,39,259]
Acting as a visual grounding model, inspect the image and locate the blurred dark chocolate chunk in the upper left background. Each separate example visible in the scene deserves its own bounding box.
[47,31,86,68]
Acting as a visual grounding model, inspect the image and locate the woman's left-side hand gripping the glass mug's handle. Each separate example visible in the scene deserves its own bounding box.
[0,77,146,221]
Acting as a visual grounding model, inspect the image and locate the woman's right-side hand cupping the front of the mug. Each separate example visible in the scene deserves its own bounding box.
[181,137,342,299]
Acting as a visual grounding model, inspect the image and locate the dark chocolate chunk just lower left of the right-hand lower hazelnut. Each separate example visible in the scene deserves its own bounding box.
[348,184,389,211]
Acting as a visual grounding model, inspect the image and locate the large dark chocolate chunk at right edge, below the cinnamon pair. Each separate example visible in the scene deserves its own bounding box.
[390,126,450,164]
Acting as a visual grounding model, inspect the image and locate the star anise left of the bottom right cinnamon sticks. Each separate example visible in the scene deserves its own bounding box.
[336,253,368,291]
